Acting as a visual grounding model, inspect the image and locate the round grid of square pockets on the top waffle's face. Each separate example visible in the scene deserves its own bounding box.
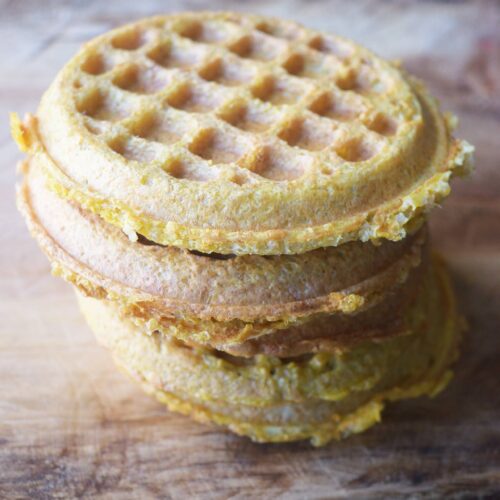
[73,15,401,185]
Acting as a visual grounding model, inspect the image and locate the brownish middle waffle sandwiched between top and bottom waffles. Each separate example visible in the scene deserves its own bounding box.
[18,160,427,356]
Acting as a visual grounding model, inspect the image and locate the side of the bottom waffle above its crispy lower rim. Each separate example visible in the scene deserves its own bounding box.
[79,258,456,408]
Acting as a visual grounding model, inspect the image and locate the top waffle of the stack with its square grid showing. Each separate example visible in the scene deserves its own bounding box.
[10,13,472,254]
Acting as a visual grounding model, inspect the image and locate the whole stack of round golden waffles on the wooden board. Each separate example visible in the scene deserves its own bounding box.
[13,13,472,445]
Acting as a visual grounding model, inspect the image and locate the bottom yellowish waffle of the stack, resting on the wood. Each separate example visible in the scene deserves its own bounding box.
[79,263,459,444]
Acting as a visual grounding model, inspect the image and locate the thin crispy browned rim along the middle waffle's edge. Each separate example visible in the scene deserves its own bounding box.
[17,160,426,332]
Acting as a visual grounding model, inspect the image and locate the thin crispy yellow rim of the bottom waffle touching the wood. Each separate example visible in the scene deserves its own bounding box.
[79,258,464,446]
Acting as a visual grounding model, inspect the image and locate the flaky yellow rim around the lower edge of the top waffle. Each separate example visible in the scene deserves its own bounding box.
[18,110,474,255]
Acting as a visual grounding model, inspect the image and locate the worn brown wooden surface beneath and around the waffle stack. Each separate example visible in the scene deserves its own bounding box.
[0,0,500,499]
